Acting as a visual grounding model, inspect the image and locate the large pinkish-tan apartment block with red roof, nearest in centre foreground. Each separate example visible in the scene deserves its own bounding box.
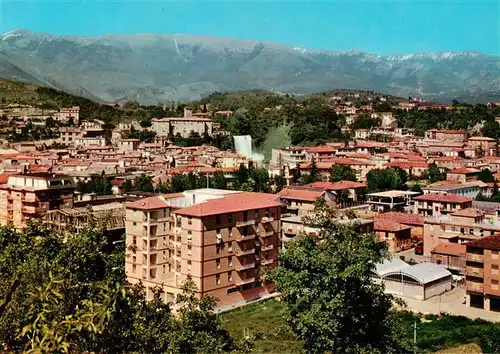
[126,190,281,306]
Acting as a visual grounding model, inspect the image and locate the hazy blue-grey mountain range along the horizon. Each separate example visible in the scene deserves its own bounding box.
[0,30,500,104]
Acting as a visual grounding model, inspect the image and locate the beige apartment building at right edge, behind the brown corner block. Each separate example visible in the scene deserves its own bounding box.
[424,208,500,257]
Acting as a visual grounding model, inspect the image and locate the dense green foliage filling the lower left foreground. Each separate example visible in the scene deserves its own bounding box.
[0,225,244,353]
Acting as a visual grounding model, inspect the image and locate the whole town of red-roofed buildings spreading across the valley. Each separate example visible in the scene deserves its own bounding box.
[0,81,500,352]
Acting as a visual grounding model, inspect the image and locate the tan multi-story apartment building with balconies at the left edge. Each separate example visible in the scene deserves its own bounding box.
[0,173,75,229]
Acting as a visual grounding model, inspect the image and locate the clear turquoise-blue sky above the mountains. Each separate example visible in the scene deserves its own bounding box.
[0,0,500,55]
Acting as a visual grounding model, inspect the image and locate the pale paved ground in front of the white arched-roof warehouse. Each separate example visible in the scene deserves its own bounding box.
[394,286,500,322]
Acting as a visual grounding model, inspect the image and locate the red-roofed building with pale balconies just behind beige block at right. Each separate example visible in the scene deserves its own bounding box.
[413,193,472,216]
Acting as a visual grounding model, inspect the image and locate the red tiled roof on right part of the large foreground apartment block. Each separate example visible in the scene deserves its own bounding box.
[175,192,281,217]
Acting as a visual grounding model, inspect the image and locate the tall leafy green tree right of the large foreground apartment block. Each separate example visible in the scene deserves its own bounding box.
[271,203,409,354]
